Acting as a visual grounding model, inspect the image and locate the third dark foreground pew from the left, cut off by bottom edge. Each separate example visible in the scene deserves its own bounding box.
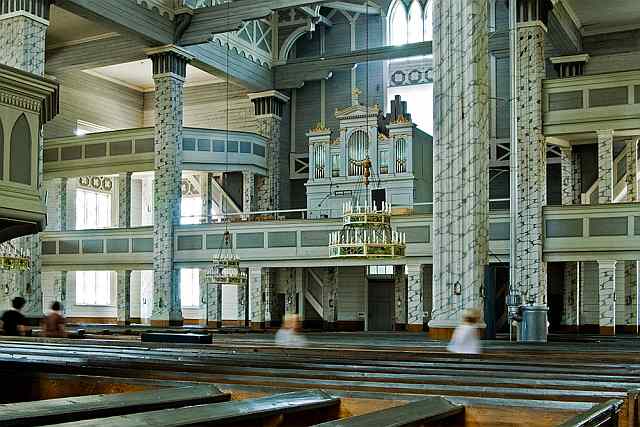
[317,397,464,427]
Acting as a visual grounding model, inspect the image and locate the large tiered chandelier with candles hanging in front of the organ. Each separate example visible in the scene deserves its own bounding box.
[329,158,406,259]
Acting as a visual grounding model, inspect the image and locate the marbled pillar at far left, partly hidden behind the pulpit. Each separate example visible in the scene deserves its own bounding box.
[0,0,51,321]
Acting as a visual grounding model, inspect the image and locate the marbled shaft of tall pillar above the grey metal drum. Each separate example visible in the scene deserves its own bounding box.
[512,21,547,304]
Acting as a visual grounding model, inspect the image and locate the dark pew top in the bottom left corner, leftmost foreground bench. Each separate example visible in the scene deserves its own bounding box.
[0,384,230,426]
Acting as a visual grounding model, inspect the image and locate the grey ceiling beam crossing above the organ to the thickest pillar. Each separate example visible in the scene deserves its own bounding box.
[275,41,433,89]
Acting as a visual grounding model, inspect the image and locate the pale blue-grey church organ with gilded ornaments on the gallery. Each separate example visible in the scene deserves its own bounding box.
[306,91,433,218]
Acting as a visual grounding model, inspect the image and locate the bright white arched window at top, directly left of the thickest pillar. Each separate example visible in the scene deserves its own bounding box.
[388,0,433,45]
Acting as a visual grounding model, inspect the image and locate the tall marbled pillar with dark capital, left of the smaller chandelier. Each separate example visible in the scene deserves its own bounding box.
[147,46,191,327]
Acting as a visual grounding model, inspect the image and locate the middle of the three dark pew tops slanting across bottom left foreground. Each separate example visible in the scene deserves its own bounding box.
[45,390,340,427]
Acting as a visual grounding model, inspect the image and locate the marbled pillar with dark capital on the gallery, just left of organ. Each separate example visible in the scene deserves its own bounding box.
[249,90,289,211]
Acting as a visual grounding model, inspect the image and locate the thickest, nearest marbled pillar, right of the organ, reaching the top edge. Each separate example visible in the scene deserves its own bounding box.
[430,0,489,336]
